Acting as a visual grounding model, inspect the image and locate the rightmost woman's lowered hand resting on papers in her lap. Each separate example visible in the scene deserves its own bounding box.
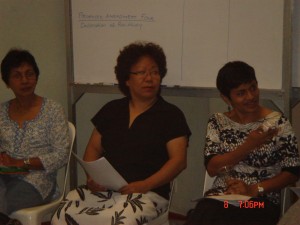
[225,179,257,197]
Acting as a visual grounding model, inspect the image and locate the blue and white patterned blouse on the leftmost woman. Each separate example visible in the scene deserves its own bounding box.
[0,98,69,198]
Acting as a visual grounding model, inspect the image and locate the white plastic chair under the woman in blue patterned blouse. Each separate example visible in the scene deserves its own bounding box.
[10,122,76,225]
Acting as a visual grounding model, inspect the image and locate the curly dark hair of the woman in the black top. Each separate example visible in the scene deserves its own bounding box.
[115,42,167,97]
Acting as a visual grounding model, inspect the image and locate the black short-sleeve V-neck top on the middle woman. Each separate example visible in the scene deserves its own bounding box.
[92,97,191,199]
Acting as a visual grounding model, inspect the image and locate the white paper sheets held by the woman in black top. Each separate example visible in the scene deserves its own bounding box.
[72,152,128,191]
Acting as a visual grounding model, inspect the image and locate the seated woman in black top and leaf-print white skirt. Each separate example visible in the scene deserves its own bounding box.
[52,42,191,225]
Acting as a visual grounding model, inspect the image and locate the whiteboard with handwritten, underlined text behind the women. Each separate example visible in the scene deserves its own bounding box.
[70,0,284,89]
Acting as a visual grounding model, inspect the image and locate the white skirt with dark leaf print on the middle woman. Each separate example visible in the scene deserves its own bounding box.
[52,185,168,225]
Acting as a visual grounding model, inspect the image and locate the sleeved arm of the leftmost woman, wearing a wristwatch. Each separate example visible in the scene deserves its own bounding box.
[0,100,69,173]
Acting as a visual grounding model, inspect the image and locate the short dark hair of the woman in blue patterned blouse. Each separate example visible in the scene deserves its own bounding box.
[1,48,40,85]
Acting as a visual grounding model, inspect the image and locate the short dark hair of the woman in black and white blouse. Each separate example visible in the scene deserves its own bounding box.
[217,61,257,99]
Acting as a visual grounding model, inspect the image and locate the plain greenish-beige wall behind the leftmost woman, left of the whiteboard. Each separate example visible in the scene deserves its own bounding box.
[0,0,67,112]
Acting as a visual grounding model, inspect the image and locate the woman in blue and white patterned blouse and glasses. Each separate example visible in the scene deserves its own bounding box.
[0,49,69,225]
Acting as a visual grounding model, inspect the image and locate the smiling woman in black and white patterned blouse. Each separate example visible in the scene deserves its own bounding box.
[186,61,300,225]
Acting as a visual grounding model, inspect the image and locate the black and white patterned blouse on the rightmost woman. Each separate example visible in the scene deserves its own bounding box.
[204,111,300,204]
